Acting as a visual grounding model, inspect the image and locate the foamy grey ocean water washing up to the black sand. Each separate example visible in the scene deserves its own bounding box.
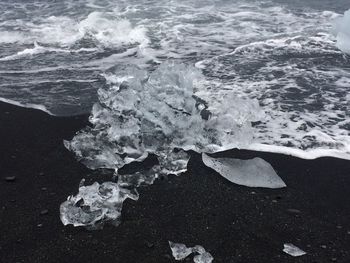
[0,0,350,159]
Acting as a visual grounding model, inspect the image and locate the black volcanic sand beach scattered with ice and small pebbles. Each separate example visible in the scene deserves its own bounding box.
[0,103,350,263]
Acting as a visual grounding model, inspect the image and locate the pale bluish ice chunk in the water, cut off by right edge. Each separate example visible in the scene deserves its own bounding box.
[334,10,350,55]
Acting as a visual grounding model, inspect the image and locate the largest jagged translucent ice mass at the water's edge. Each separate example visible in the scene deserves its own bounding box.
[65,62,257,178]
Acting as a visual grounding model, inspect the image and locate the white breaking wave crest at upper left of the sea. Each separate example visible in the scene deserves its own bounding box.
[0,11,148,46]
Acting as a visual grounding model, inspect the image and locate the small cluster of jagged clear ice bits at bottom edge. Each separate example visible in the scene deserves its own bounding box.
[169,241,214,263]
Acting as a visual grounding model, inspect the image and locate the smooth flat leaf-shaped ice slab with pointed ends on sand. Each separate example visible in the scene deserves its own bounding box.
[202,154,286,188]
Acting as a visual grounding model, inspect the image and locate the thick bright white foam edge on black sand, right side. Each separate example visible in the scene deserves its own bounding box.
[240,143,350,160]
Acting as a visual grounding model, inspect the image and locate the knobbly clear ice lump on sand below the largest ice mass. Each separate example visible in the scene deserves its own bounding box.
[60,182,138,229]
